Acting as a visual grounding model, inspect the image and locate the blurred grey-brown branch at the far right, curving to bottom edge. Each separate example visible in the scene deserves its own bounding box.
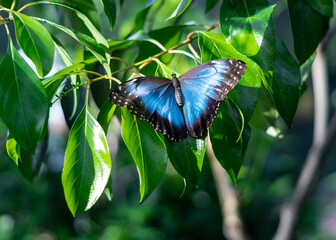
[273,46,336,240]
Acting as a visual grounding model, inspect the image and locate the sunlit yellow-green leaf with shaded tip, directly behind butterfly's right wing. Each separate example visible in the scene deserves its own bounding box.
[198,32,265,122]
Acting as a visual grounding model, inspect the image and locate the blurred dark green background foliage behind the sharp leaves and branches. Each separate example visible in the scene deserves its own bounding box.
[0,0,336,240]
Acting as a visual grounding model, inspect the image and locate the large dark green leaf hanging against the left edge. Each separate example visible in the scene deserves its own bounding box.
[0,39,49,153]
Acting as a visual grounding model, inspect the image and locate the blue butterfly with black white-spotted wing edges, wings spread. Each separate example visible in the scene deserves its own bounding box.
[110,59,246,141]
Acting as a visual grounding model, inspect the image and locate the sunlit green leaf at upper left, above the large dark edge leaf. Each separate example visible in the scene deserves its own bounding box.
[12,11,55,77]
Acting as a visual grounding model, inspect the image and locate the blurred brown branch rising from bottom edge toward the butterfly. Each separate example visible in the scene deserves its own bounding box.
[207,140,248,240]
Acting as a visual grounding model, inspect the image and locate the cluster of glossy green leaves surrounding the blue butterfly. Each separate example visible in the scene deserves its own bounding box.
[0,0,333,215]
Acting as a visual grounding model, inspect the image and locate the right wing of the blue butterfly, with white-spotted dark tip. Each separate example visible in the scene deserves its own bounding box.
[179,59,246,138]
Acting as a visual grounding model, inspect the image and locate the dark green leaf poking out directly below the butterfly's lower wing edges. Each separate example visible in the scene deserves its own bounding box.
[165,135,208,186]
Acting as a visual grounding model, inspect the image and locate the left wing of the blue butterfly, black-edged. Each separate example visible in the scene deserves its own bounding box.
[110,77,187,141]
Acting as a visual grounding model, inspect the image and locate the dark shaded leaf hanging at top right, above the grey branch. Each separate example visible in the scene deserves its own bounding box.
[288,0,329,64]
